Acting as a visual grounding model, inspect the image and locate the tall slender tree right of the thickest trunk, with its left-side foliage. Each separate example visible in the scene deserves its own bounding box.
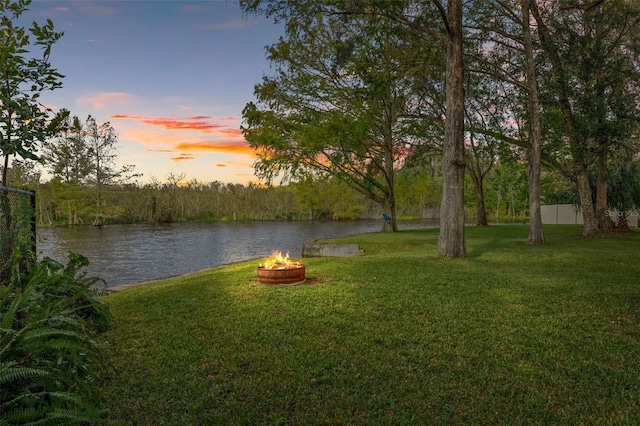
[460,0,545,240]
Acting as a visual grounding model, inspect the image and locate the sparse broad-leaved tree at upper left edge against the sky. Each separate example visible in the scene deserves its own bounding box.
[0,0,63,185]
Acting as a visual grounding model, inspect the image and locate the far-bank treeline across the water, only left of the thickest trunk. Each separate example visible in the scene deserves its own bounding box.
[29,172,441,226]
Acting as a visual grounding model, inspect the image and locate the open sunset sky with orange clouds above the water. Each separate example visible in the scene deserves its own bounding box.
[23,0,283,184]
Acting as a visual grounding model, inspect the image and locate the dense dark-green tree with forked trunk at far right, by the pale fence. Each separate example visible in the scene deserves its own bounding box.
[531,0,640,235]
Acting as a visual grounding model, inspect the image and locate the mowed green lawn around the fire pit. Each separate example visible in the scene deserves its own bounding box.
[96,225,640,425]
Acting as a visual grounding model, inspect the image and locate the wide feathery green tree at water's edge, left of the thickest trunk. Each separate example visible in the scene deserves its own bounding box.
[243,1,436,231]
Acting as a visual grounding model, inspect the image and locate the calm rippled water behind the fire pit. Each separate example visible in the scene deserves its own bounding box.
[37,220,437,287]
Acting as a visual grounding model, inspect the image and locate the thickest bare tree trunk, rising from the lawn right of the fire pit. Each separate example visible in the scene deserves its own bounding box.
[438,0,467,259]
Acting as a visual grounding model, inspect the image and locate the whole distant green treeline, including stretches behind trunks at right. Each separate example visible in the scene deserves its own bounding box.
[9,155,577,226]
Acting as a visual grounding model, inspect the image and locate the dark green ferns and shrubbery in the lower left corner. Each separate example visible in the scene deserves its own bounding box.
[0,253,111,426]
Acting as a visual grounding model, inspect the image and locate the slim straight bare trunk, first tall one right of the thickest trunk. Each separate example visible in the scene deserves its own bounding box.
[522,0,545,244]
